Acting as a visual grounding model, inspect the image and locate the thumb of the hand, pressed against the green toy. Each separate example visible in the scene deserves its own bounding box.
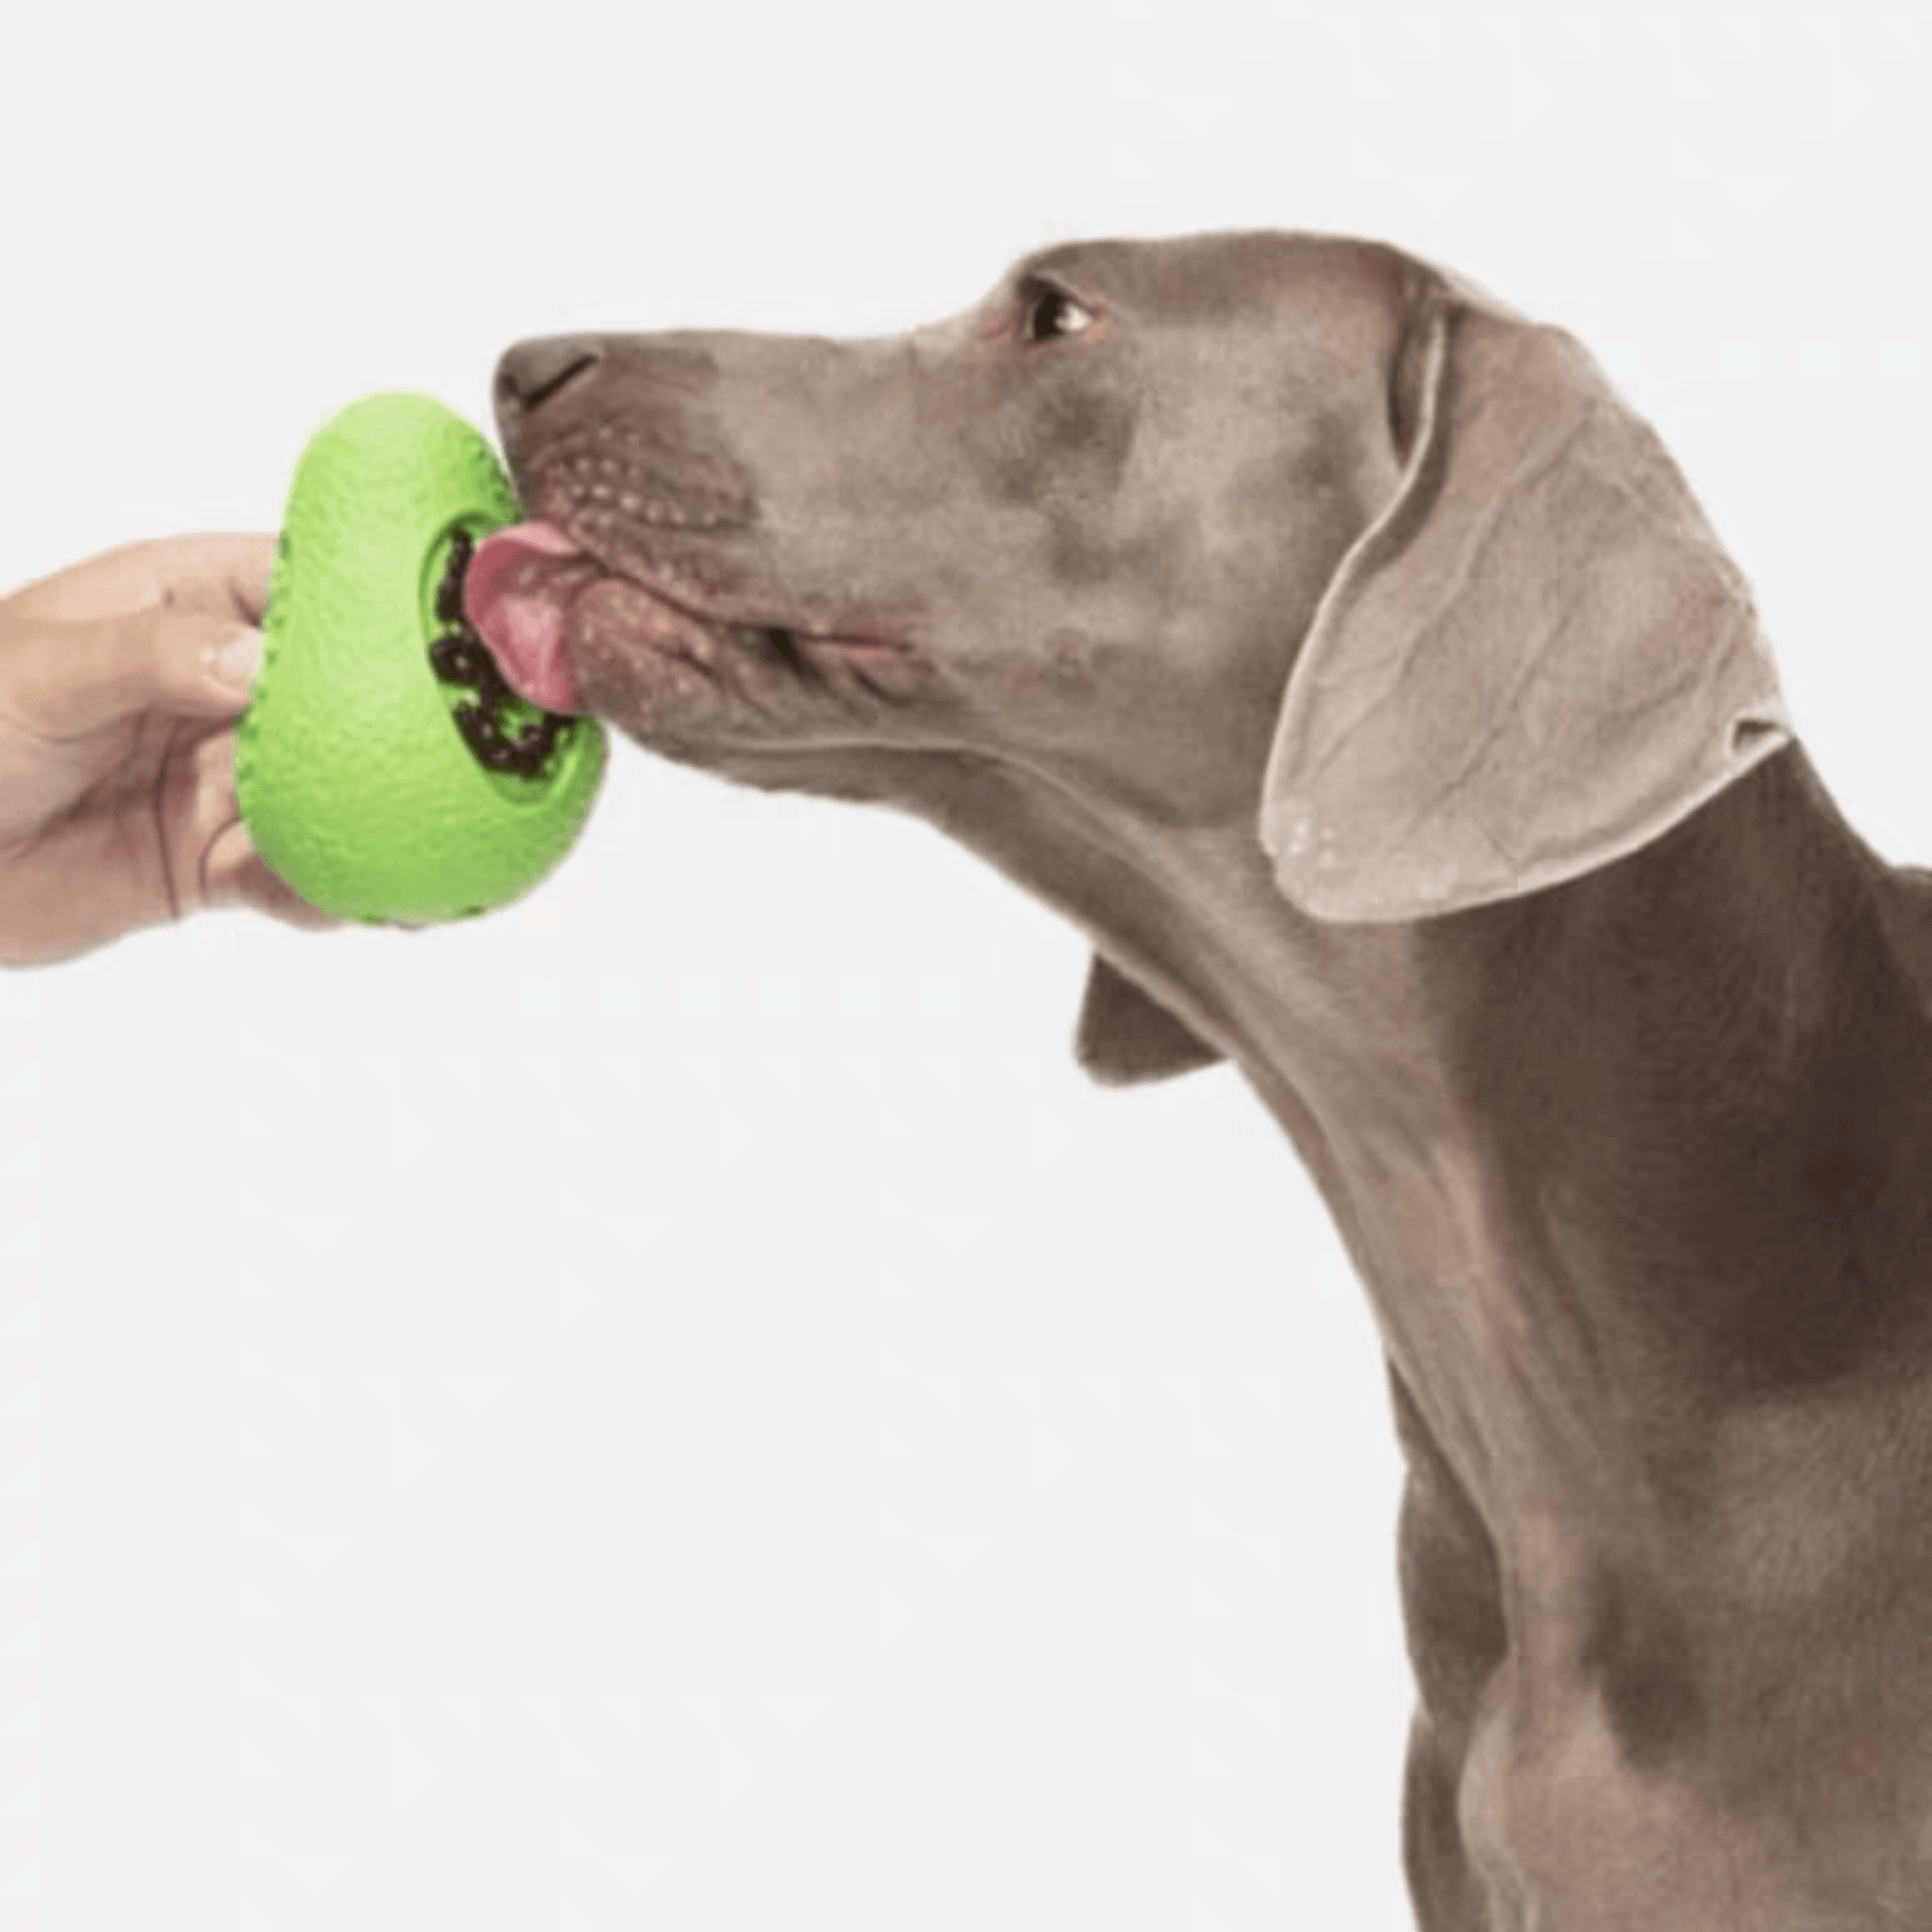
[8,603,261,738]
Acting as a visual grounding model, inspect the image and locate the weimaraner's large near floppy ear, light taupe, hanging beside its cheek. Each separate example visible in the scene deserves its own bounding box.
[1262,280,1791,919]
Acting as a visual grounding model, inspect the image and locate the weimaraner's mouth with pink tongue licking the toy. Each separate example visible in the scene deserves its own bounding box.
[462,519,910,730]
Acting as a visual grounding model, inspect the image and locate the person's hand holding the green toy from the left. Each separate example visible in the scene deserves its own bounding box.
[0,535,342,966]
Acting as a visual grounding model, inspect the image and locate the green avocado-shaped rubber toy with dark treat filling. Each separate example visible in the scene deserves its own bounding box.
[233,390,605,923]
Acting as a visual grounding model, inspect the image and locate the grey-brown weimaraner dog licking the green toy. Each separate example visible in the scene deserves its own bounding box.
[468,233,1932,1932]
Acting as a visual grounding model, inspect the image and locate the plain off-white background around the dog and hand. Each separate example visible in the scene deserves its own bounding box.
[0,0,1932,1932]
